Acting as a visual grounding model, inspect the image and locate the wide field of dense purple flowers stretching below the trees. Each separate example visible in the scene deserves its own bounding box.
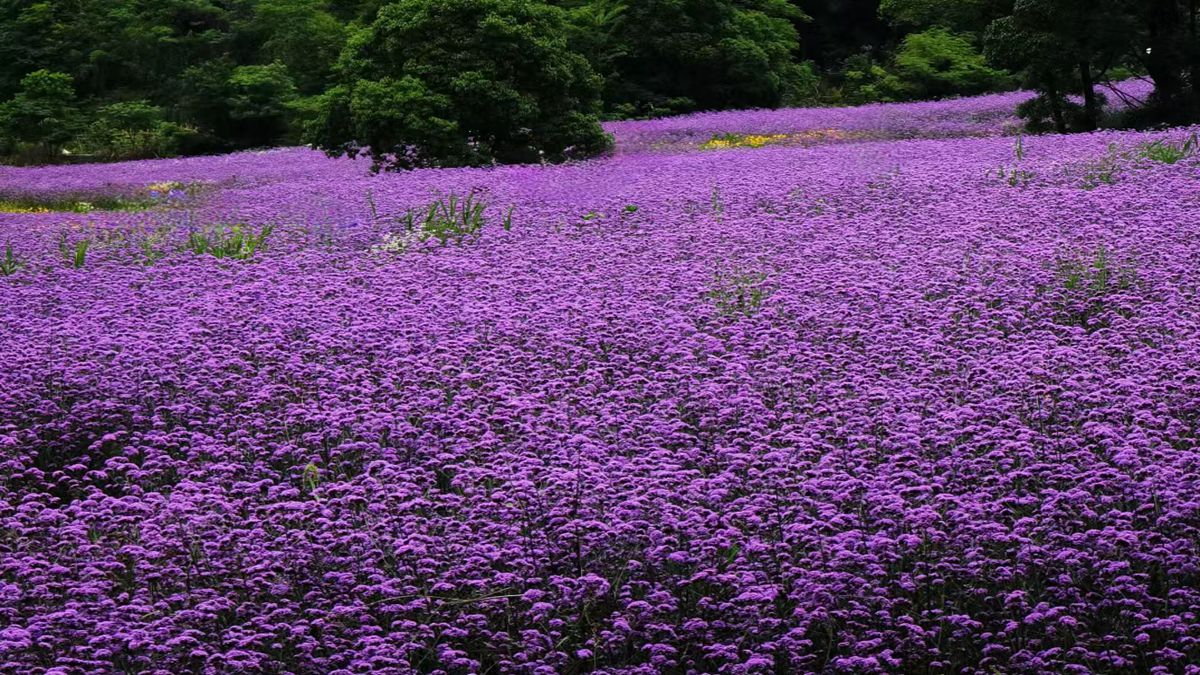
[0,90,1200,675]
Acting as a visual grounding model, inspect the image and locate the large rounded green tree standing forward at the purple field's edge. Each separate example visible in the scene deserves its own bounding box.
[307,0,610,168]
